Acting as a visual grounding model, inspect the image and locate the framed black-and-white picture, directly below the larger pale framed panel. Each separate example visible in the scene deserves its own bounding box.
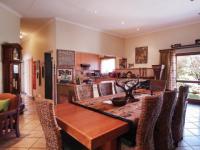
[57,68,73,83]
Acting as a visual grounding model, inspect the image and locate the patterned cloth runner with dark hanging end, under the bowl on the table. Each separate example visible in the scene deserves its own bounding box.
[73,93,150,146]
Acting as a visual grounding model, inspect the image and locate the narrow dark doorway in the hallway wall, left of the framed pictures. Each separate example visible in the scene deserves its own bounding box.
[44,53,53,99]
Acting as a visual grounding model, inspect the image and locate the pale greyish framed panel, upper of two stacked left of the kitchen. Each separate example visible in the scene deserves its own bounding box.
[57,49,75,68]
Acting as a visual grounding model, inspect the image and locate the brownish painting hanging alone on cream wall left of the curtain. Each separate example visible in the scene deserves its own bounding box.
[135,46,148,64]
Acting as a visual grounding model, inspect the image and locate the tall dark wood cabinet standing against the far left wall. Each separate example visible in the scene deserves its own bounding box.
[2,43,22,95]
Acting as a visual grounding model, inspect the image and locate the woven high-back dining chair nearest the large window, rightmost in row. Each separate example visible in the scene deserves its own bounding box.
[172,86,189,147]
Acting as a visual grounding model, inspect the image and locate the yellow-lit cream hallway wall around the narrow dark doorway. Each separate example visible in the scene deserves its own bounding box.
[22,20,56,97]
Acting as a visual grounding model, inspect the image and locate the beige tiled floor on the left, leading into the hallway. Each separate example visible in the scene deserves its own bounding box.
[0,95,46,150]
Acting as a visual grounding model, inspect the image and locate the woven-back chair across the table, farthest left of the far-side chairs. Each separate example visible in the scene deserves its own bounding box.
[75,84,94,100]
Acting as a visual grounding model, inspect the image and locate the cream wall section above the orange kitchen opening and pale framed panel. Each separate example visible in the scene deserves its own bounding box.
[56,19,125,56]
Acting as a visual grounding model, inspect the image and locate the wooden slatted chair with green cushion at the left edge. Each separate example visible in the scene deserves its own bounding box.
[0,93,20,137]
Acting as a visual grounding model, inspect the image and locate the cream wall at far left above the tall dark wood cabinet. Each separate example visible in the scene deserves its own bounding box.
[0,4,20,92]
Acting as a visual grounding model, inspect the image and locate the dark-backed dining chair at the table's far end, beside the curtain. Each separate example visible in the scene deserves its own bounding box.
[149,80,166,94]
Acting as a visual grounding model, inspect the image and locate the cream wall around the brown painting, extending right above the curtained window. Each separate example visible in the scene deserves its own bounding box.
[125,23,200,68]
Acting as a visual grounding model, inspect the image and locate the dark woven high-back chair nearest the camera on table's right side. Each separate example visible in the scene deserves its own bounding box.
[121,94,163,150]
